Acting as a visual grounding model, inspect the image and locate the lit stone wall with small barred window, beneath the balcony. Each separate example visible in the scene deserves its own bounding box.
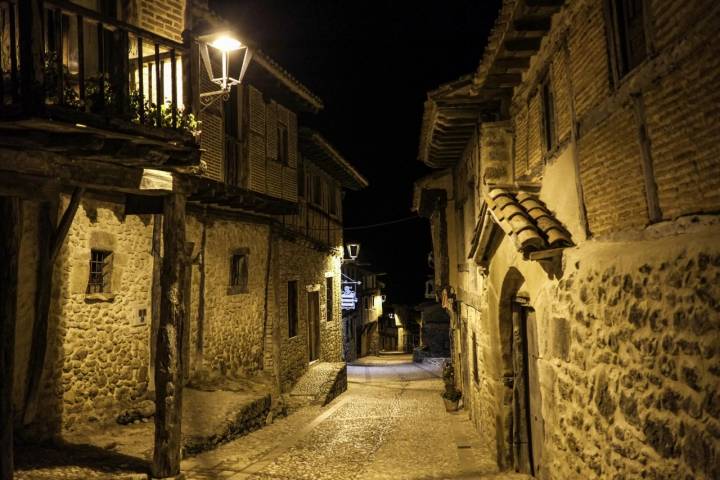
[39,199,152,428]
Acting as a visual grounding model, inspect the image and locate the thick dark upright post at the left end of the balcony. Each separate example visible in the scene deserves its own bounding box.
[17,0,45,114]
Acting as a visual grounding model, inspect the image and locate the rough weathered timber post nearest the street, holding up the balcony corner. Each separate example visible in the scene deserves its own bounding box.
[152,193,187,479]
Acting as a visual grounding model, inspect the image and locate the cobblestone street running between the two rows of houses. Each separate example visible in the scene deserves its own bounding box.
[183,357,527,480]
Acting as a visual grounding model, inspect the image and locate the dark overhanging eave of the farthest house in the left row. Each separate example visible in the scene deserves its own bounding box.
[299,128,368,190]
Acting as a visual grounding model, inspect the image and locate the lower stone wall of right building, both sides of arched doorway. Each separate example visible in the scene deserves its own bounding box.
[455,220,720,479]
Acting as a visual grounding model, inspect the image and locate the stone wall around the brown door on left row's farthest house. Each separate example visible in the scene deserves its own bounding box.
[275,240,342,391]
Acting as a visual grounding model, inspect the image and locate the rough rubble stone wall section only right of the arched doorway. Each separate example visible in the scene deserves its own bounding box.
[545,229,720,479]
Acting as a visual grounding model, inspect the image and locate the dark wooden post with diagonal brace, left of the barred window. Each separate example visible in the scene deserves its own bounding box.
[23,187,85,424]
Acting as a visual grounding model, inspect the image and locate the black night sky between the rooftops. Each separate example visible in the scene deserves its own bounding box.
[210,0,501,303]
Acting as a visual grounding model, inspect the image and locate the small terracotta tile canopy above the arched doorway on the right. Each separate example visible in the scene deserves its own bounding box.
[486,188,573,255]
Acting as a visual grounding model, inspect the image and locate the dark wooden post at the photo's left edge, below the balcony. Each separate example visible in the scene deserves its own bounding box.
[0,197,22,480]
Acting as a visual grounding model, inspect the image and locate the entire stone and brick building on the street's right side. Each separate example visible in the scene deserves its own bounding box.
[414,0,720,479]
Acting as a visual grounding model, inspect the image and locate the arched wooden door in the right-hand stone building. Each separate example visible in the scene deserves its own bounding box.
[508,296,544,475]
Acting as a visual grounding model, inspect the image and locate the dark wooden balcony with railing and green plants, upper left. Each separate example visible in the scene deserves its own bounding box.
[0,0,200,166]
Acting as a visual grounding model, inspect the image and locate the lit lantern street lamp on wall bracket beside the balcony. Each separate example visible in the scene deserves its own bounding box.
[198,32,252,111]
